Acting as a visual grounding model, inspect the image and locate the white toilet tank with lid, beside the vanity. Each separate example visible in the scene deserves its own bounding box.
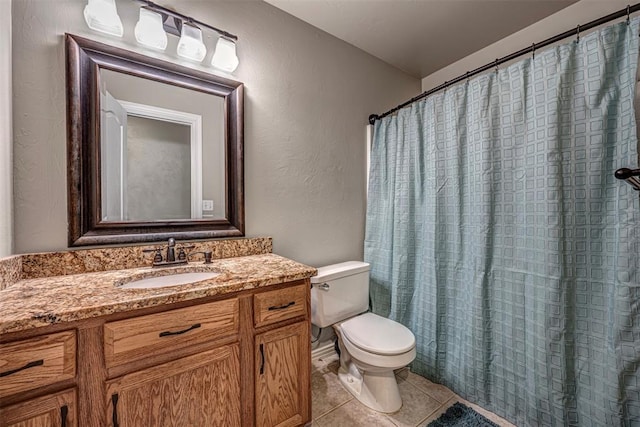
[311,261,369,328]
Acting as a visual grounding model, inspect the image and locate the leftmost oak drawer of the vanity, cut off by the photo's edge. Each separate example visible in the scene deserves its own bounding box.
[0,331,76,398]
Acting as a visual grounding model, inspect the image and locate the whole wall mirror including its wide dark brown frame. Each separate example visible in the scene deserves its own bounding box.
[66,34,244,246]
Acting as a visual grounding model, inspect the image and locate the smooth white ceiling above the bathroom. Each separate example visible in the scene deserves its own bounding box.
[265,0,577,78]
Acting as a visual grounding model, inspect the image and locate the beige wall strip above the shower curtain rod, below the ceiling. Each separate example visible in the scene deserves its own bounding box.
[422,0,629,92]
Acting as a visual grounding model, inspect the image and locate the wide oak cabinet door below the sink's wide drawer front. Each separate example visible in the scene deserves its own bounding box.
[106,344,240,427]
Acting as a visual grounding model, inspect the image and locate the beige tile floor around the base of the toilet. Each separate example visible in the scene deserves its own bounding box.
[311,355,514,427]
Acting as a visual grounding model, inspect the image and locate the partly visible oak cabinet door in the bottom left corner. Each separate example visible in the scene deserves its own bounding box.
[0,389,78,427]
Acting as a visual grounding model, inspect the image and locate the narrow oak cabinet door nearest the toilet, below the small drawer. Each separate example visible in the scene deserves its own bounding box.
[256,322,311,427]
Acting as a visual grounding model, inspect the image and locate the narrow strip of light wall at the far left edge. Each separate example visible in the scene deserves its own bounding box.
[0,0,13,258]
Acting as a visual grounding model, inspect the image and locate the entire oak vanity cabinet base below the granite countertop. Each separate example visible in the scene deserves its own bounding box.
[0,279,311,427]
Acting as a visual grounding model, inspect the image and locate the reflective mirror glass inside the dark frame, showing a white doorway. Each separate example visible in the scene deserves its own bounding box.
[100,69,225,221]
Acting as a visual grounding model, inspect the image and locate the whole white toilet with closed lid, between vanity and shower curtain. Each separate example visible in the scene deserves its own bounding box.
[311,261,416,413]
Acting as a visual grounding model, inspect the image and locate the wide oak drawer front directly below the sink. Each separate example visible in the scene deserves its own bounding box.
[104,298,238,367]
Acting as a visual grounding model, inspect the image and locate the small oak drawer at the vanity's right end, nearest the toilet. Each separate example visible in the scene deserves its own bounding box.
[253,285,308,327]
